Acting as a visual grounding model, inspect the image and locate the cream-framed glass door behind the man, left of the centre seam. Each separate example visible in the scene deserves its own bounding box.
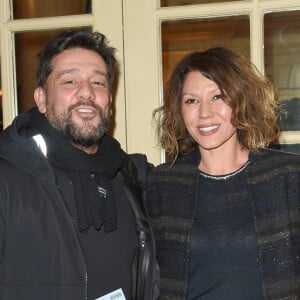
[0,0,127,150]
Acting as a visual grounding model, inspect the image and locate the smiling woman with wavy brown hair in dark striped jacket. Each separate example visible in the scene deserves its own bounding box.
[147,47,300,300]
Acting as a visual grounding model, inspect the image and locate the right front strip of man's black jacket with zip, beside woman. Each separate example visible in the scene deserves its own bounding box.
[120,154,159,300]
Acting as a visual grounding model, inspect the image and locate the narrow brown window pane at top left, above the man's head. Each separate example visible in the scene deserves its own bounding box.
[13,0,91,19]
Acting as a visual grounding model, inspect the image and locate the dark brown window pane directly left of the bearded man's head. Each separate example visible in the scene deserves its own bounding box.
[15,28,91,113]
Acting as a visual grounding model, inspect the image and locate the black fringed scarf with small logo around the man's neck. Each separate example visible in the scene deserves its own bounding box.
[30,109,124,232]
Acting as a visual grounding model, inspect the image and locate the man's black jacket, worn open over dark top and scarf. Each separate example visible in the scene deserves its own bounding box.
[0,109,157,300]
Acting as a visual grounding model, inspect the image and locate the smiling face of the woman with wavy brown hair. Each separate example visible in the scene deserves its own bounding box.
[181,71,238,151]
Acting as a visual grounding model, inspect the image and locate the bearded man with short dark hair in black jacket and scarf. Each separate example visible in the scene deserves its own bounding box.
[0,31,156,300]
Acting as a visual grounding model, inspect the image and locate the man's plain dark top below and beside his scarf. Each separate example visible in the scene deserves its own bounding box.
[50,164,138,300]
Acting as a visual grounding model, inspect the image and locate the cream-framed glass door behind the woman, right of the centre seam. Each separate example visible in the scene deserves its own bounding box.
[124,0,300,164]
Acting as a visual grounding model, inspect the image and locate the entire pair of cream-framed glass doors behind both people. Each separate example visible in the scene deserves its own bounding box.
[0,0,300,164]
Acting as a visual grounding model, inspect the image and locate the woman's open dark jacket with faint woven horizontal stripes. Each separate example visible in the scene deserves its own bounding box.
[147,149,300,300]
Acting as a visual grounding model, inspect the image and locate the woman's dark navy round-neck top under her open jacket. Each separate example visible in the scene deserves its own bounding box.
[188,166,263,300]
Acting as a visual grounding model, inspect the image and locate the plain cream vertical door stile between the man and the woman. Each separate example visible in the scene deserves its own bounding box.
[124,0,161,164]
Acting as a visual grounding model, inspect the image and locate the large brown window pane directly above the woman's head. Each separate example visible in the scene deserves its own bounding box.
[161,16,250,83]
